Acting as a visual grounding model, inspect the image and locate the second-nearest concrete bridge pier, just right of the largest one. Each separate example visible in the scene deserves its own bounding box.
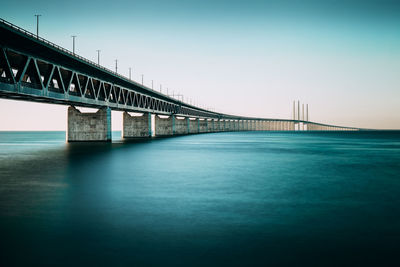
[122,111,151,138]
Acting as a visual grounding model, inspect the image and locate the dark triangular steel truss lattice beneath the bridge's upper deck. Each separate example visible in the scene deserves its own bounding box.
[0,47,217,117]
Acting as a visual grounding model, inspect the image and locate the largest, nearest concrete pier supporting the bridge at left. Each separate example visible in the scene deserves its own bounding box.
[67,106,111,142]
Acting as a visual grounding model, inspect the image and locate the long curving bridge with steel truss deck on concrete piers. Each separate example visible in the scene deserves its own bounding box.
[0,19,359,142]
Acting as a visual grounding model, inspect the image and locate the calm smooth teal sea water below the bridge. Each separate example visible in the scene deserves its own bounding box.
[0,132,400,266]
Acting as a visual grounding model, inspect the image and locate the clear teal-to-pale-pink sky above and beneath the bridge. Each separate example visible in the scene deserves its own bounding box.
[0,0,400,130]
